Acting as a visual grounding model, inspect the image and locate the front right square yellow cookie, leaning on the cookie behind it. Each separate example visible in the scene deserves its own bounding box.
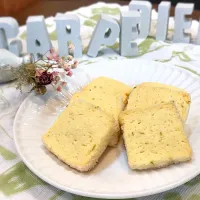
[120,103,192,170]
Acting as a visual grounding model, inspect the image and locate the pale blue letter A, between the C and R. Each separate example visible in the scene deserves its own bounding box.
[27,16,52,59]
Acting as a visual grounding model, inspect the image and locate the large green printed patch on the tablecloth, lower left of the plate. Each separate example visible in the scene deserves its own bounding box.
[0,162,46,196]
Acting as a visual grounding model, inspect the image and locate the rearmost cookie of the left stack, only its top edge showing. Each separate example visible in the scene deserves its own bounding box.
[83,77,132,104]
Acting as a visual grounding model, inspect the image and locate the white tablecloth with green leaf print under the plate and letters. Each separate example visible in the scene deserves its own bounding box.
[0,3,200,200]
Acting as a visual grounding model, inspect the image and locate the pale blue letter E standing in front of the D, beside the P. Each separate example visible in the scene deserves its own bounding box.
[120,11,140,56]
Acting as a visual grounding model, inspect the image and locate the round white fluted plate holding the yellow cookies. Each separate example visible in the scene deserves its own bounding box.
[14,60,200,199]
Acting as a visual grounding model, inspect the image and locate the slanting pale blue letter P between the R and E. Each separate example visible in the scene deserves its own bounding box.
[87,14,120,57]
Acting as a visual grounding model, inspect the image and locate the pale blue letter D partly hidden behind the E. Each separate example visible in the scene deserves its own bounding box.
[129,0,152,38]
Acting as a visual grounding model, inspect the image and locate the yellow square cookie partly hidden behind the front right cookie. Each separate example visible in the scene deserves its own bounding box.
[126,85,191,121]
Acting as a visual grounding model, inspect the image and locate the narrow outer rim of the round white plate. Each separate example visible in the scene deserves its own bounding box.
[13,59,200,199]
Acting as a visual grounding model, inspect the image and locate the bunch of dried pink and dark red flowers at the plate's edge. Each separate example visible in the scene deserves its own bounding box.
[16,45,78,94]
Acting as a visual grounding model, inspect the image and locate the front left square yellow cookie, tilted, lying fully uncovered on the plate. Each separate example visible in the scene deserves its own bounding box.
[42,100,116,171]
